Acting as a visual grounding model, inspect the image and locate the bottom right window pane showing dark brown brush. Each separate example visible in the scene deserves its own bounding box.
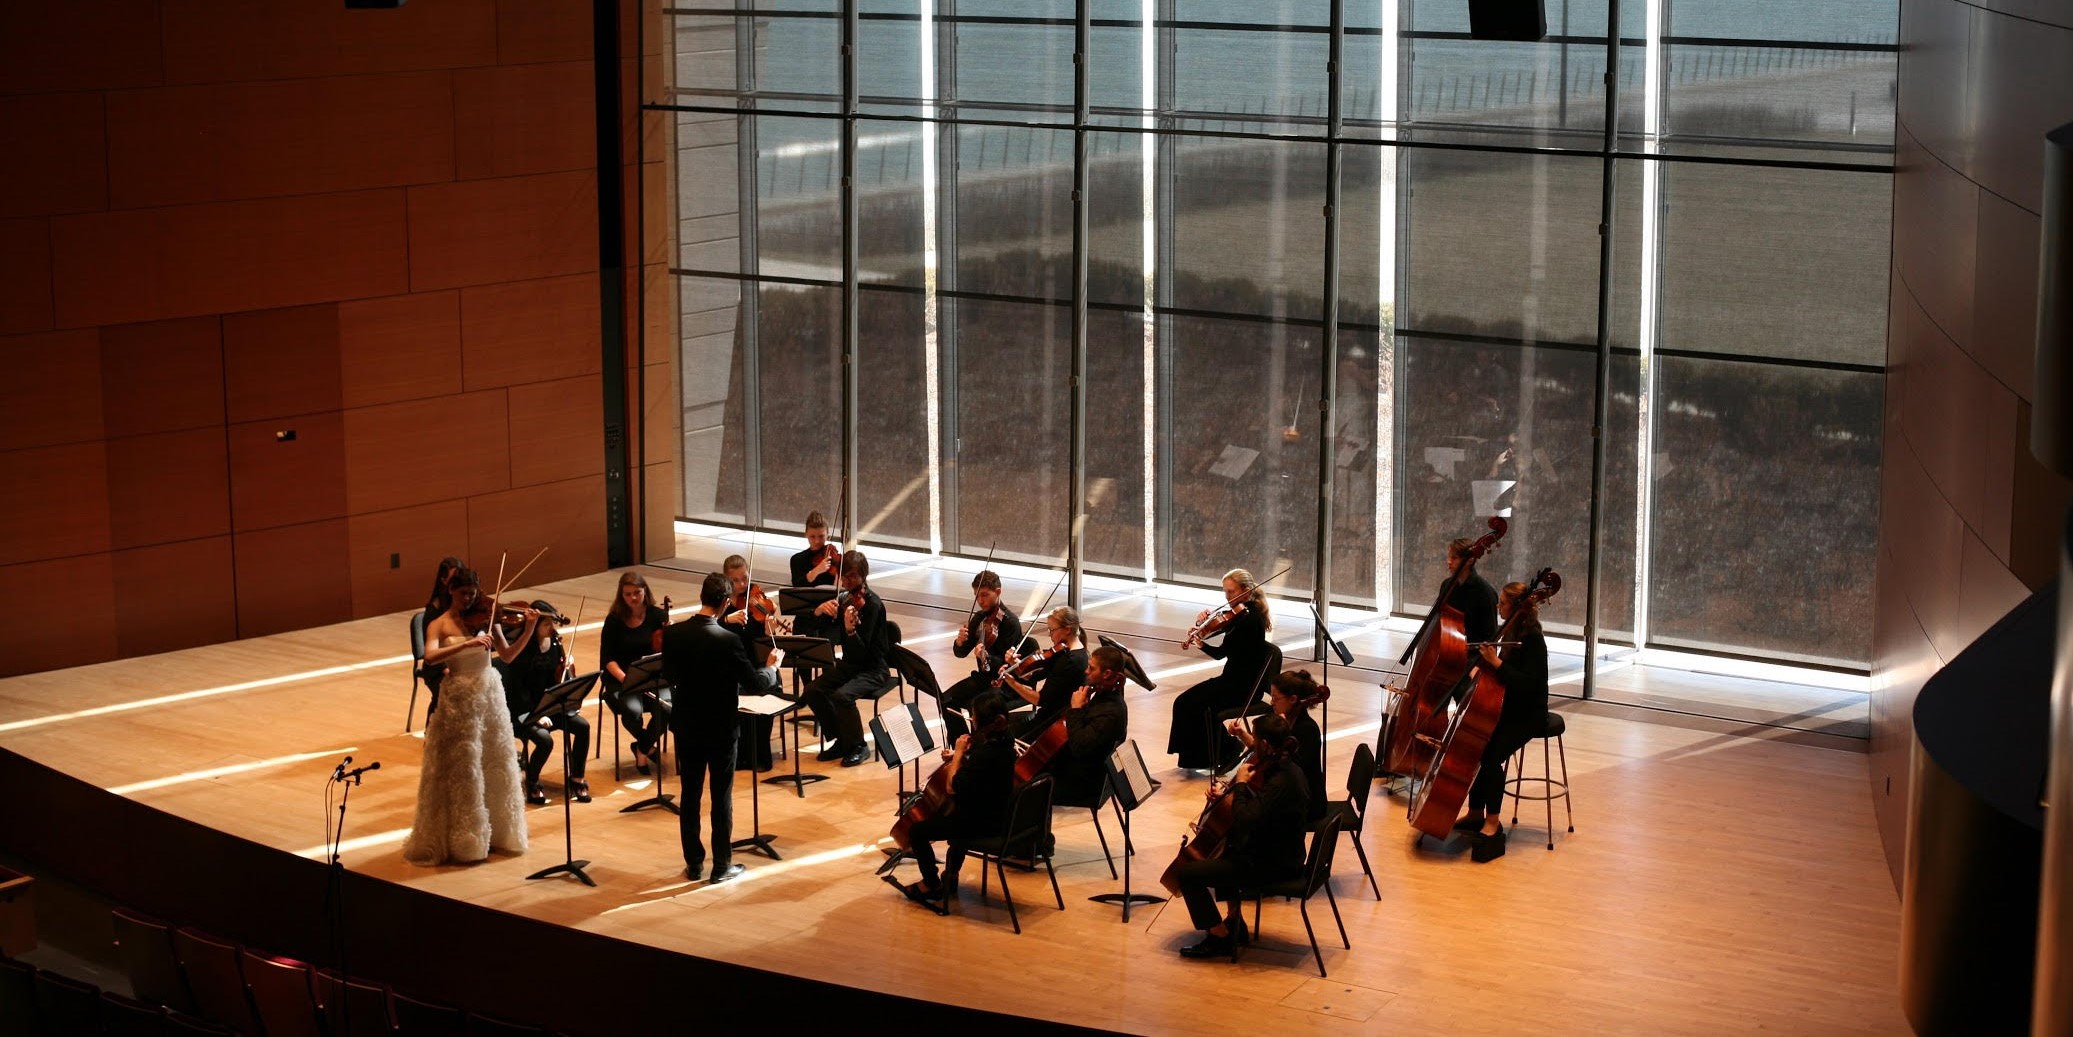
[1648,357,1884,668]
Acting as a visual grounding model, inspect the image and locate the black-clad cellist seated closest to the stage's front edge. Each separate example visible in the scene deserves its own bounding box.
[1175,713,1310,958]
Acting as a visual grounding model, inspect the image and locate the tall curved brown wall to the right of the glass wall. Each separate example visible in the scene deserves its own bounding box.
[1872,0,2073,884]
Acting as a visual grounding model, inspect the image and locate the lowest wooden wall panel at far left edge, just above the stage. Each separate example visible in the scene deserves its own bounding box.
[0,554,116,676]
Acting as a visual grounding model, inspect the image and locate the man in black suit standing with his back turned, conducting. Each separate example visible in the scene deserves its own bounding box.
[661,572,779,881]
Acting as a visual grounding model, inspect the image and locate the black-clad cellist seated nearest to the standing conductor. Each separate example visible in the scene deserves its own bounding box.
[885,695,1016,915]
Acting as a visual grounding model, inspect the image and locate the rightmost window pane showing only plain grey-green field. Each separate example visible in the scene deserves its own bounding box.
[1658,162,1893,367]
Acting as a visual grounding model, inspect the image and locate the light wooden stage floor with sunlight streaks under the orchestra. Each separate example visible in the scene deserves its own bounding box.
[0,537,1907,1033]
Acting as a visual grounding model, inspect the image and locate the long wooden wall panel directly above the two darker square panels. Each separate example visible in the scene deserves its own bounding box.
[52,191,408,326]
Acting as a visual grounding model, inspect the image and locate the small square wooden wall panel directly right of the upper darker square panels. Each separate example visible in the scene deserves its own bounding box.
[338,292,460,407]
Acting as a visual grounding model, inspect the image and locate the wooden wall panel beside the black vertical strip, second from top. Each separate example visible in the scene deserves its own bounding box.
[454,62,597,180]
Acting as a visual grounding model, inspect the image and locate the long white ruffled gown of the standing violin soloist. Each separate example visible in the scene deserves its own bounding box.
[402,637,527,867]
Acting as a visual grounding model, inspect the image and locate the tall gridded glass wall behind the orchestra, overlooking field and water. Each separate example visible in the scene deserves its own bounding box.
[653,0,1897,670]
